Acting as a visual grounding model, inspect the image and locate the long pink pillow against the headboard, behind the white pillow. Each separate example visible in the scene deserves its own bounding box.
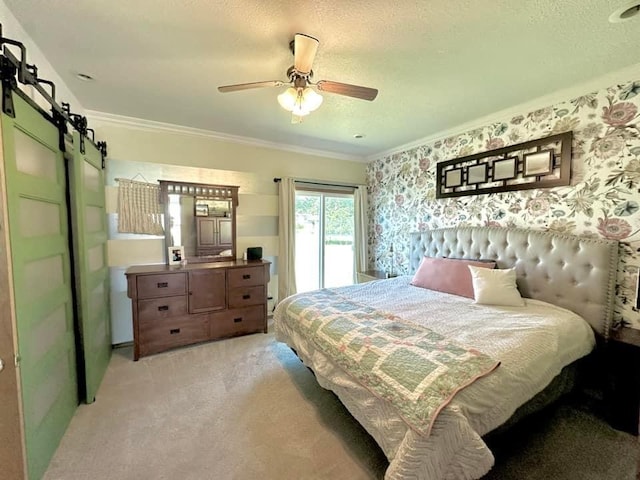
[411,257,496,298]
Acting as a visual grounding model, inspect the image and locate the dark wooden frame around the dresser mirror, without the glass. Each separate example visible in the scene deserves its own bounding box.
[158,180,240,263]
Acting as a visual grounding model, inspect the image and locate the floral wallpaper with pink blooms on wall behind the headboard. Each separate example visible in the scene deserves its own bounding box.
[367,81,640,329]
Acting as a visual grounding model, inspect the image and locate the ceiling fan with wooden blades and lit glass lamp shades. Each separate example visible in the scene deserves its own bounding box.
[218,33,378,123]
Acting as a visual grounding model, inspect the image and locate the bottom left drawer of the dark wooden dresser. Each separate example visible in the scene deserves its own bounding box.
[139,316,209,355]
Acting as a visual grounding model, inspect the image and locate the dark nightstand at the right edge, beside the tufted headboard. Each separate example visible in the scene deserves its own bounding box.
[605,328,640,435]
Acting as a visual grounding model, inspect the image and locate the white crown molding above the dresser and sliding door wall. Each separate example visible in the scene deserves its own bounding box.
[86,110,367,162]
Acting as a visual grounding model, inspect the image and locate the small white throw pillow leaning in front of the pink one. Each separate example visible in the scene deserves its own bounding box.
[469,265,524,307]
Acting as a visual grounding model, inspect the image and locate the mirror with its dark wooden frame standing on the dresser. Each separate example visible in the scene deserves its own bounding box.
[159,180,239,262]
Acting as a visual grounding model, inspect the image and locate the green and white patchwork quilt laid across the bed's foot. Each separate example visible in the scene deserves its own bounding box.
[285,290,500,436]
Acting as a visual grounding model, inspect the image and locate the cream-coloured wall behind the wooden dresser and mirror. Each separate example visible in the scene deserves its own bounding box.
[90,117,366,344]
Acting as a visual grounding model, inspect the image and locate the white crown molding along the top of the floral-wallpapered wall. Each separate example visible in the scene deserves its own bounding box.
[366,63,640,162]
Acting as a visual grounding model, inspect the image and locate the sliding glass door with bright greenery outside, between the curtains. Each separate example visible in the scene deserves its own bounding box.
[296,190,354,292]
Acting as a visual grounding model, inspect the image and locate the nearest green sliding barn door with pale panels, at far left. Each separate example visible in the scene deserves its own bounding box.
[0,94,78,480]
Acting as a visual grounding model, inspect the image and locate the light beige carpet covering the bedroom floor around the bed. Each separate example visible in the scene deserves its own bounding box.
[45,326,637,480]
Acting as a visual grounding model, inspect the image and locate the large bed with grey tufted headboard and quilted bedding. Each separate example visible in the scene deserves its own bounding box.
[274,227,618,480]
